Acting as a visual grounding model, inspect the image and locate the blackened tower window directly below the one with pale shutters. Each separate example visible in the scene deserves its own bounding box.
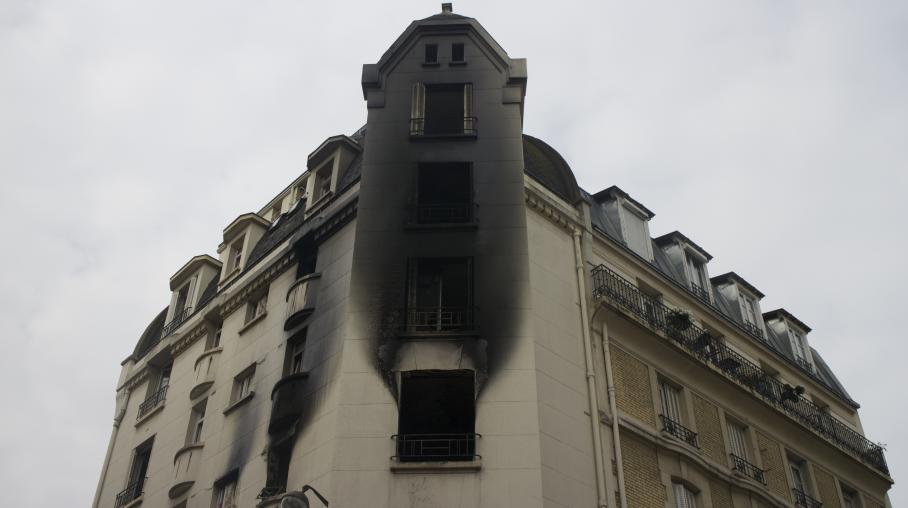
[416,162,473,224]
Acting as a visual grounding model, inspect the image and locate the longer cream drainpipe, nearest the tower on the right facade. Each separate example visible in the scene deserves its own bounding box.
[573,228,608,508]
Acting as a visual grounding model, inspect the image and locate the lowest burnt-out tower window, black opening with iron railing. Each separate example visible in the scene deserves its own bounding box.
[397,370,476,462]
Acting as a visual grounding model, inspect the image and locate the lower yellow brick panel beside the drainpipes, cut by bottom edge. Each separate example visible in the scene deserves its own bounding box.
[621,432,667,508]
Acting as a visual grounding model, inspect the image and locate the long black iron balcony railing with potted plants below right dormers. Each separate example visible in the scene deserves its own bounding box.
[592,265,889,475]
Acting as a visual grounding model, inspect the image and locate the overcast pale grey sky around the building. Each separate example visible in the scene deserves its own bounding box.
[0,0,908,507]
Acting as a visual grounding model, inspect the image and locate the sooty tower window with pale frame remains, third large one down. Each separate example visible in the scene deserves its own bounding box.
[406,258,473,332]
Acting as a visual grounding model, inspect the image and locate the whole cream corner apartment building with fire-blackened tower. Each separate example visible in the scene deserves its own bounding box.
[94,4,892,508]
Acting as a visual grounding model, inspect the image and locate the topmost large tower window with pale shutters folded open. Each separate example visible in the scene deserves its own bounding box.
[410,83,476,136]
